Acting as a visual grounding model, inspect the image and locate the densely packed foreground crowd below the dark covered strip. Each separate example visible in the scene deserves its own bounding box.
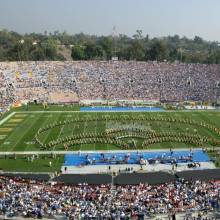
[0,177,220,219]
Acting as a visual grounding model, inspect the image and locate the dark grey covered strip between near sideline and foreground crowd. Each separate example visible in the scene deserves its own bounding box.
[0,169,220,185]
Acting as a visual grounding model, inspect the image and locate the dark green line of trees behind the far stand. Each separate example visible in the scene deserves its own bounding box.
[0,30,220,64]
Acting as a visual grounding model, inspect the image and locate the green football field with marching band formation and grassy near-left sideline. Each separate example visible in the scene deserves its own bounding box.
[0,105,220,172]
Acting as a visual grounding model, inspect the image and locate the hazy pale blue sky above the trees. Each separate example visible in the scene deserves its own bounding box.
[0,0,220,41]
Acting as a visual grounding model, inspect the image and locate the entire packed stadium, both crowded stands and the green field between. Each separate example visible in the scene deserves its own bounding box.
[0,61,220,219]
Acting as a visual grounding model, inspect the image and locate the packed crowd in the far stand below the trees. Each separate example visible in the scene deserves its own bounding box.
[0,61,220,113]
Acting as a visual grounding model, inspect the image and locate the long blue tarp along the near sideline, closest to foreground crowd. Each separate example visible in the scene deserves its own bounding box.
[64,150,210,166]
